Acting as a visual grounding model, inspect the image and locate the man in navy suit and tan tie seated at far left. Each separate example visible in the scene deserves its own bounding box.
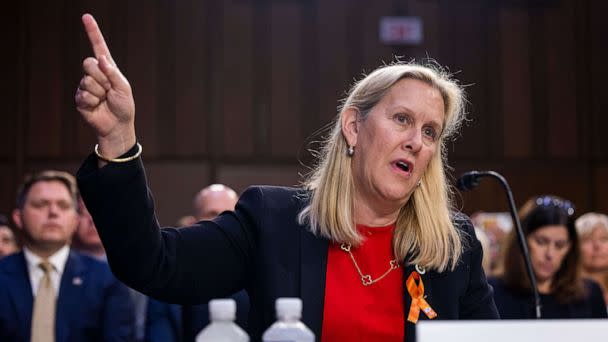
[0,171,133,342]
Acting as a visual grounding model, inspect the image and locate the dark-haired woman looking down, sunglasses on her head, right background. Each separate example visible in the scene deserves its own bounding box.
[490,196,607,319]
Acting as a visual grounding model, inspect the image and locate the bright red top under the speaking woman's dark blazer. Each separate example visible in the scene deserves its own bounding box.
[321,225,405,342]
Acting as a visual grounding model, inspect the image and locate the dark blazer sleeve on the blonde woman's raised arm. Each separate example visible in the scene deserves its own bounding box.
[77,155,264,304]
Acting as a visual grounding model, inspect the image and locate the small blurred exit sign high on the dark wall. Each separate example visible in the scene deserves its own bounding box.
[380,17,423,45]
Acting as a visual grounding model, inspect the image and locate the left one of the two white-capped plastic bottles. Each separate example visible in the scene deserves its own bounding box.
[196,299,249,342]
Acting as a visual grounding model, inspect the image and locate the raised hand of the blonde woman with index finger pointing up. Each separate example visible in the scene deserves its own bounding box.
[75,14,136,158]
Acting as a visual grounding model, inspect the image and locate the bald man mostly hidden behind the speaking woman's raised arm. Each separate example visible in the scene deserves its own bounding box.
[145,184,249,342]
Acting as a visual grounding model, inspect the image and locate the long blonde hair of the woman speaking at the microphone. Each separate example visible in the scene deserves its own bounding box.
[298,62,465,272]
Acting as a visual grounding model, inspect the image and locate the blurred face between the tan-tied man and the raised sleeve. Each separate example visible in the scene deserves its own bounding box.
[72,198,106,260]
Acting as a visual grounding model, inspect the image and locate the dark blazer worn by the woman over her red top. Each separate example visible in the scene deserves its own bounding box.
[77,155,498,341]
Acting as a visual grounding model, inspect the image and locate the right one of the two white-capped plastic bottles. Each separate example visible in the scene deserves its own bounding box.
[262,298,315,342]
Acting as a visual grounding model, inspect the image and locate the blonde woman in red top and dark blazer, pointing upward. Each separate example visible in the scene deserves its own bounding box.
[76,15,497,341]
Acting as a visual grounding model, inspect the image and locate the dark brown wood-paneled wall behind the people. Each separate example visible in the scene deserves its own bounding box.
[0,0,608,224]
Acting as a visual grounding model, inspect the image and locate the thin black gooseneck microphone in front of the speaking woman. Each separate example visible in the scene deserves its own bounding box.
[456,171,541,319]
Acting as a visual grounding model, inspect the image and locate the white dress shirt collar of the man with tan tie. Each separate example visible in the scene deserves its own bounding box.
[23,245,70,297]
